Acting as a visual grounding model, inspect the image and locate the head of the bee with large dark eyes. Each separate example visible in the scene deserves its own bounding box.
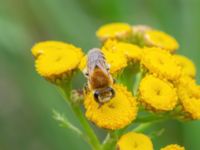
[94,87,115,104]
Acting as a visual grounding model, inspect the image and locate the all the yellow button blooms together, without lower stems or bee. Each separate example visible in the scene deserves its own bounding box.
[32,23,200,150]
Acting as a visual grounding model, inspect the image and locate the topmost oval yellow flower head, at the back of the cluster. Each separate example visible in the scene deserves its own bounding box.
[96,23,132,41]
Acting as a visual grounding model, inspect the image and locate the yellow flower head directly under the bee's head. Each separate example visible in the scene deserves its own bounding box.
[84,84,137,130]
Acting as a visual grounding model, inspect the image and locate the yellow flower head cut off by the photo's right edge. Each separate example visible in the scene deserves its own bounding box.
[178,76,200,119]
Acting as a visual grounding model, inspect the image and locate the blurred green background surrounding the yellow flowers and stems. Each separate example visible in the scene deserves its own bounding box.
[0,0,200,150]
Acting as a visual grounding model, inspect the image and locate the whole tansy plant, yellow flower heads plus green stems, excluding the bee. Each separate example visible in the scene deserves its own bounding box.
[32,23,200,150]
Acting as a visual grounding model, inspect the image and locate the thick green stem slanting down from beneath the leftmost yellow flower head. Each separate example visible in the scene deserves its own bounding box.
[57,83,101,150]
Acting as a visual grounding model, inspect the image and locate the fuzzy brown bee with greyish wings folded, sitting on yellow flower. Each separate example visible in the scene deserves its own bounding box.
[85,48,115,106]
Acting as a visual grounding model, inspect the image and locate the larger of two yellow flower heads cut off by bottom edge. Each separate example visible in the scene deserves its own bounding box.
[117,132,153,150]
